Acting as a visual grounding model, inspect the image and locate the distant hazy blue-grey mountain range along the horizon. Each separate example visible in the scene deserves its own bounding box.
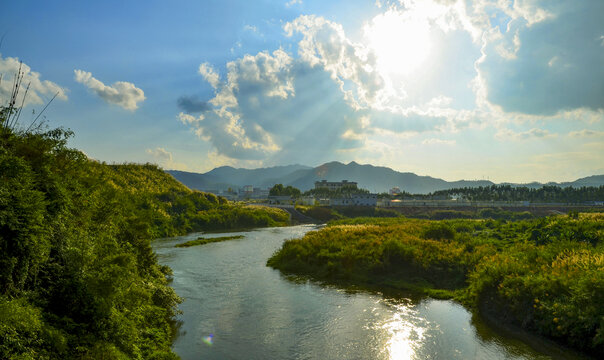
[167,161,604,194]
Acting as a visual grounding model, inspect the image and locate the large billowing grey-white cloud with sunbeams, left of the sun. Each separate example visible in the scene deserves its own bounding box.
[179,16,464,163]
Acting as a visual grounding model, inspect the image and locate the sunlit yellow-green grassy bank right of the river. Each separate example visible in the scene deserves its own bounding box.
[268,213,604,355]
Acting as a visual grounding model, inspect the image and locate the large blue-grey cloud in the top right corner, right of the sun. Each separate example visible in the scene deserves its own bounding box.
[477,0,604,115]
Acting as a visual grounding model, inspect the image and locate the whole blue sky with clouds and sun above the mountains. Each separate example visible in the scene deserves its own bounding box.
[0,0,604,182]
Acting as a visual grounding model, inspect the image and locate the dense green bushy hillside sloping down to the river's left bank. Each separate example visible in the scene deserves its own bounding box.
[0,112,288,359]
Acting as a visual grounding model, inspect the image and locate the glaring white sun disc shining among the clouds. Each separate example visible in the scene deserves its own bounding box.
[364,11,431,75]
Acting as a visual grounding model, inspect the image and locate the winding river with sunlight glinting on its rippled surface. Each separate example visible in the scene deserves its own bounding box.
[153,226,584,360]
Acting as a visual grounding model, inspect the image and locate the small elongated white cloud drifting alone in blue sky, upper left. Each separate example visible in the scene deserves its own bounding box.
[74,70,145,111]
